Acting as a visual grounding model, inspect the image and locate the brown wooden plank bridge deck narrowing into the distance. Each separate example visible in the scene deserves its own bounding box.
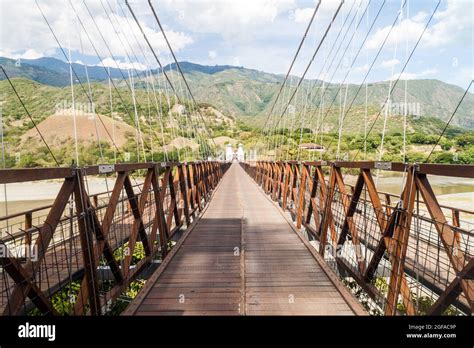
[124,164,365,315]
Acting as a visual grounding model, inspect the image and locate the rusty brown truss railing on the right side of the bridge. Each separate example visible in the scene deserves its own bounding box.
[242,161,474,315]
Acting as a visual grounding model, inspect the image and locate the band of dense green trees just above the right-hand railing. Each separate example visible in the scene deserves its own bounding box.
[240,116,474,164]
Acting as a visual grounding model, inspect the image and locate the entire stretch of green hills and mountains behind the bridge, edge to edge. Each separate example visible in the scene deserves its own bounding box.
[0,63,474,167]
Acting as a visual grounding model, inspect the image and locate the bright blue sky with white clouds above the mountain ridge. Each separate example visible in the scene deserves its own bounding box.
[0,0,474,88]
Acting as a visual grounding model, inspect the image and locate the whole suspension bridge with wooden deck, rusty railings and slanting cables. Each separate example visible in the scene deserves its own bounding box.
[0,0,474,315]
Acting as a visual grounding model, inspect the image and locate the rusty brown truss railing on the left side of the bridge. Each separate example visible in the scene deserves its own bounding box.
[0,162,229,315]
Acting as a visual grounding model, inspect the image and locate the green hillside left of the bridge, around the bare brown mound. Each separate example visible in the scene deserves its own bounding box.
[0,78,237,167]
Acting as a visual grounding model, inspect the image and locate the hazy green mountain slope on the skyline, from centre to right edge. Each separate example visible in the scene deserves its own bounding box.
[154,68,474,129]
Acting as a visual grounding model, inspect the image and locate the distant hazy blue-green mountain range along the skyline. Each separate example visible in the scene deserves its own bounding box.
[0,57,474,129]
